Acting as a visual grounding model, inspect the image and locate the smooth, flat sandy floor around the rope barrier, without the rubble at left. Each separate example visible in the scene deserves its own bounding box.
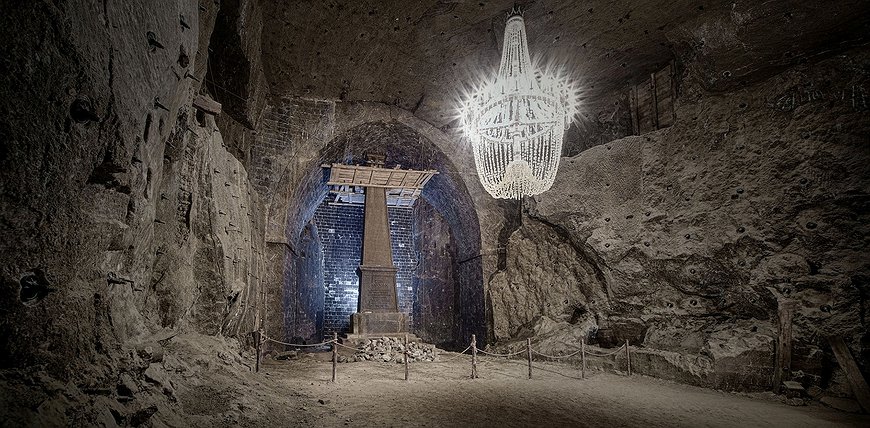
[192,354,870,428]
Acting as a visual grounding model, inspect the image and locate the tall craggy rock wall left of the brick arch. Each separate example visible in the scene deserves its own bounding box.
[0,1,264,394]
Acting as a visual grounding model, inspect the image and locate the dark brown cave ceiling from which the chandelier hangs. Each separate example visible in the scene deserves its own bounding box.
[262,0,870,127]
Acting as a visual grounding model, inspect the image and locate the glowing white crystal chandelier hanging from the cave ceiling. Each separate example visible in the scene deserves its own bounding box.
[460,10,577,199]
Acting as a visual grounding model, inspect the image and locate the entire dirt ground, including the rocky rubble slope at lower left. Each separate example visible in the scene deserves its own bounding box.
[6,334,870,428]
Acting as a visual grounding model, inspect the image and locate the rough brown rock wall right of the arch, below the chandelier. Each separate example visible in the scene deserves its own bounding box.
[489,49,870,389]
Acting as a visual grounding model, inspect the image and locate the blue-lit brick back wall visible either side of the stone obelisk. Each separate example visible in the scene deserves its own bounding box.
[314,201,416,336]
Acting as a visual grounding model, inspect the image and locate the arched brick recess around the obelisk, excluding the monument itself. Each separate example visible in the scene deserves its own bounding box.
[284,122,486,349]
